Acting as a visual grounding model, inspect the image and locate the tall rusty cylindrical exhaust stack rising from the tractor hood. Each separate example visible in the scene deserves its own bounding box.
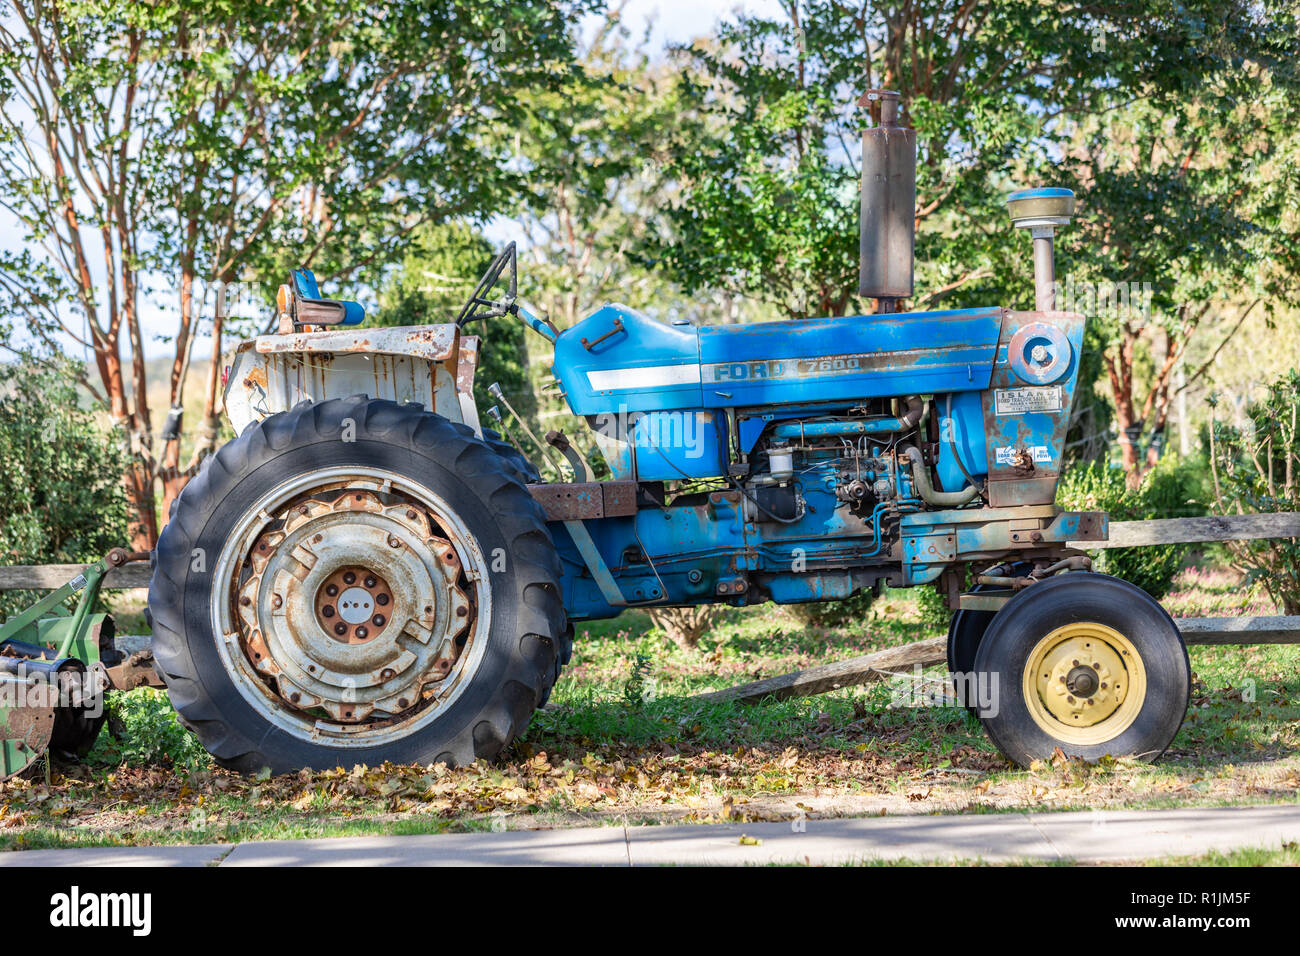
[858,90,917,312]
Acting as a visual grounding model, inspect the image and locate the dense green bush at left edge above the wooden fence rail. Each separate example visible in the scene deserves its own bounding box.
[0,360,127,618]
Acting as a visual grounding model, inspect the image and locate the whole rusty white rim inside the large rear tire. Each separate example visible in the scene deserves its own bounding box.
[211,466,491,749]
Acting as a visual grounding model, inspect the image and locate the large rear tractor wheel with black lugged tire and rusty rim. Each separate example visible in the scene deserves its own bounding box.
[150,395,566,773]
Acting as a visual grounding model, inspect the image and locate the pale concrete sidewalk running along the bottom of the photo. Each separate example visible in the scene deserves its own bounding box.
[0,805,1300,868]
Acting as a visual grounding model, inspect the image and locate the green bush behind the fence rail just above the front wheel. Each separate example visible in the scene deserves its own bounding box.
[1057,458,1197,601]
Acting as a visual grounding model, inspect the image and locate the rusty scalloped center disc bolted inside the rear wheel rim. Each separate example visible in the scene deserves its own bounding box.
[237,490,472,724]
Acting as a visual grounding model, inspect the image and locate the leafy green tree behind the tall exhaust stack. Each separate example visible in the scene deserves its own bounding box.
[657,0,1296,356]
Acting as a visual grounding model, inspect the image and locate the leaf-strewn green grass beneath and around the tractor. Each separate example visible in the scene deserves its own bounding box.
[0,561,1300,861]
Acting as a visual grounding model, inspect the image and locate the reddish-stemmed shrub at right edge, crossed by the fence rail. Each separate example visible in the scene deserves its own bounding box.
[1209,369,1300,614]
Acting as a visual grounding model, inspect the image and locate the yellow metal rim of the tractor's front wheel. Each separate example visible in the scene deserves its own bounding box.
[1023,622,1147,747]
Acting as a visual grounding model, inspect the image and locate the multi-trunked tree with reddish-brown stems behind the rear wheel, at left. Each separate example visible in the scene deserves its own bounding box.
[0,0,590,548]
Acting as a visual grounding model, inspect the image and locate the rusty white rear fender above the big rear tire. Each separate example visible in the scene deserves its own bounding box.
[225,324,481,434]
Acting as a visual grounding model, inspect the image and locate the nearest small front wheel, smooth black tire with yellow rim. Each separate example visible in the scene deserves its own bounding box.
[975,572,1191,766]
